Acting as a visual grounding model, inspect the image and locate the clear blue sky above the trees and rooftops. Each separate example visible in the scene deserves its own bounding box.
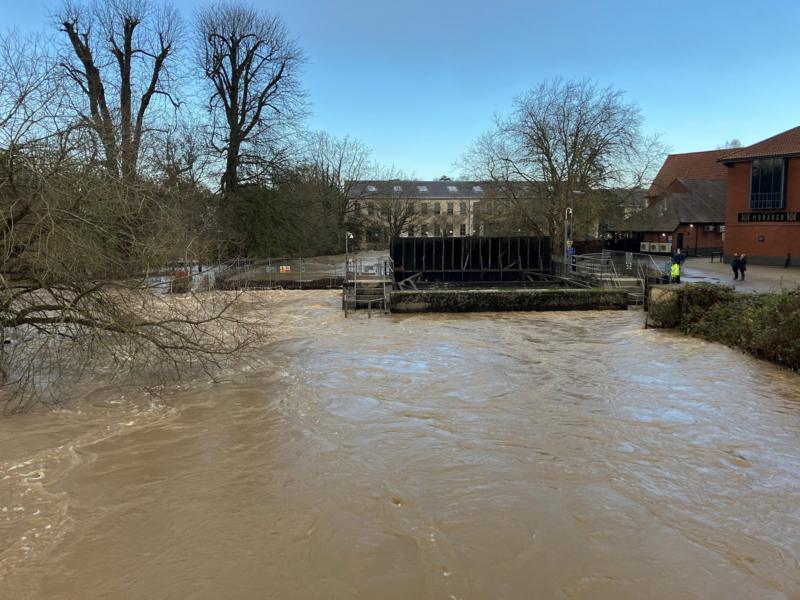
[6,0,800,179]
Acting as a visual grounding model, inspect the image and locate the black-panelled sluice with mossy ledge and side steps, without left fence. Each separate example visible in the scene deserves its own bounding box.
[342,236,664,314]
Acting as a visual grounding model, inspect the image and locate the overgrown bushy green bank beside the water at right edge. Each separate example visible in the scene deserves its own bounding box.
[648,283,800,370]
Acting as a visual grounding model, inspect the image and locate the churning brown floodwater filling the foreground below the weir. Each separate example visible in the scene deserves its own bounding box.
[0,292,800,600]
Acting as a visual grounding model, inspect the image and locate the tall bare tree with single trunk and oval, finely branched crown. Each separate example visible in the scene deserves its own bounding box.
[197,2,304,192]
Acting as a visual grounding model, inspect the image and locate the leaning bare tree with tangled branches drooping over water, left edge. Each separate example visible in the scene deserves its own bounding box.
[0,30,261,412]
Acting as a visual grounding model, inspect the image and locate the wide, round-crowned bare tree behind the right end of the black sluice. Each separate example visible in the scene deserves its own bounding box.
[462,79,663,251]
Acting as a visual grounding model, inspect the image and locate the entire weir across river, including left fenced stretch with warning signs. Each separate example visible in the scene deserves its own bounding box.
[205,236,668,316]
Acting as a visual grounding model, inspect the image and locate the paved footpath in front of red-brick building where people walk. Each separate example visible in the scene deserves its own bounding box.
[681,258,800,292]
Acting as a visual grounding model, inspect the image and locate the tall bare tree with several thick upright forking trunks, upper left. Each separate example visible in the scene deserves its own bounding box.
[58,0,180,179]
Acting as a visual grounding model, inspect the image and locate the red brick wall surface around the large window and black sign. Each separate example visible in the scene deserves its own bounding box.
[724,158,800,265]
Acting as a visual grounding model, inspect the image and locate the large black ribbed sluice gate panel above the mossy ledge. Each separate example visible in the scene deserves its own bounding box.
[391,236,551,288]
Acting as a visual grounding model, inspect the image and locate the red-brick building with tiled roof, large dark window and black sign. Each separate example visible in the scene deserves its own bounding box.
[719,127,800,265]
